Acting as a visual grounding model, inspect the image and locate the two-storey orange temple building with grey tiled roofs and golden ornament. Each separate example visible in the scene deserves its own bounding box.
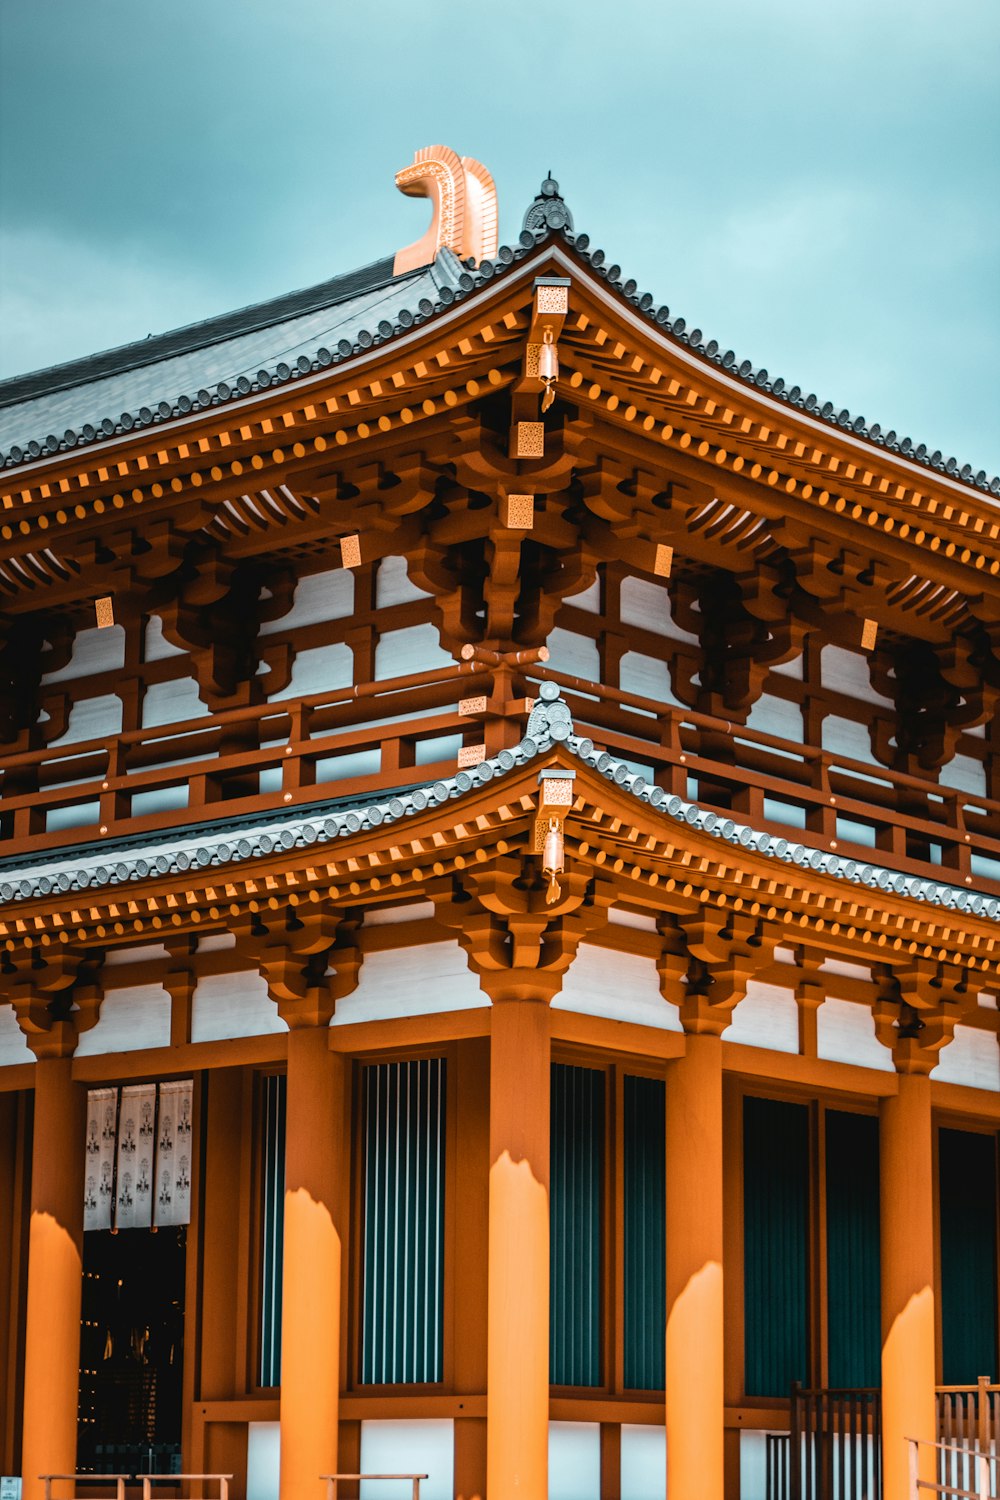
[0,147,1000,1500]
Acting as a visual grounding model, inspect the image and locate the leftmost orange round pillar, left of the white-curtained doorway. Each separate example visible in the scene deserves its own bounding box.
[21,1058,87,1500]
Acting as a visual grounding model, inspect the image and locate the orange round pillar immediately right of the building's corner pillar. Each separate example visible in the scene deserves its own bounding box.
[666,1035,724,1500]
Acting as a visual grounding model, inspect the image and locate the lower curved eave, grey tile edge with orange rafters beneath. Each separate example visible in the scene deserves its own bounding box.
[0,725,1000,989]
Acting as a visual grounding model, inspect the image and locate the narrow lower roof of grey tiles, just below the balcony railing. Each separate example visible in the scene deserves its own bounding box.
[0,683,1000,923]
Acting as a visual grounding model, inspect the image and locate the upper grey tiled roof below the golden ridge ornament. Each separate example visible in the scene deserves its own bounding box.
[0,185,1000,495]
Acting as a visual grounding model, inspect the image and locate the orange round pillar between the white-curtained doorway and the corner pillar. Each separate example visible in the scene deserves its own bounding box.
[279,1026,349,1500]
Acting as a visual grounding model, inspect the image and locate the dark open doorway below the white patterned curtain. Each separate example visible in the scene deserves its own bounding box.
[76,1229,187,1475]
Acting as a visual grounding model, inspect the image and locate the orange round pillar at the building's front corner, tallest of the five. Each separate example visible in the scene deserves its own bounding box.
[486,1001,552,1500]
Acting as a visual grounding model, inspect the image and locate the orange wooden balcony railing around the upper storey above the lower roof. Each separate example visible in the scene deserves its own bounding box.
[0,660,1000,894]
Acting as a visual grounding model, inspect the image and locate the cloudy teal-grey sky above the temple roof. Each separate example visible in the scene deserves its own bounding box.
[0,0,1000,473]
